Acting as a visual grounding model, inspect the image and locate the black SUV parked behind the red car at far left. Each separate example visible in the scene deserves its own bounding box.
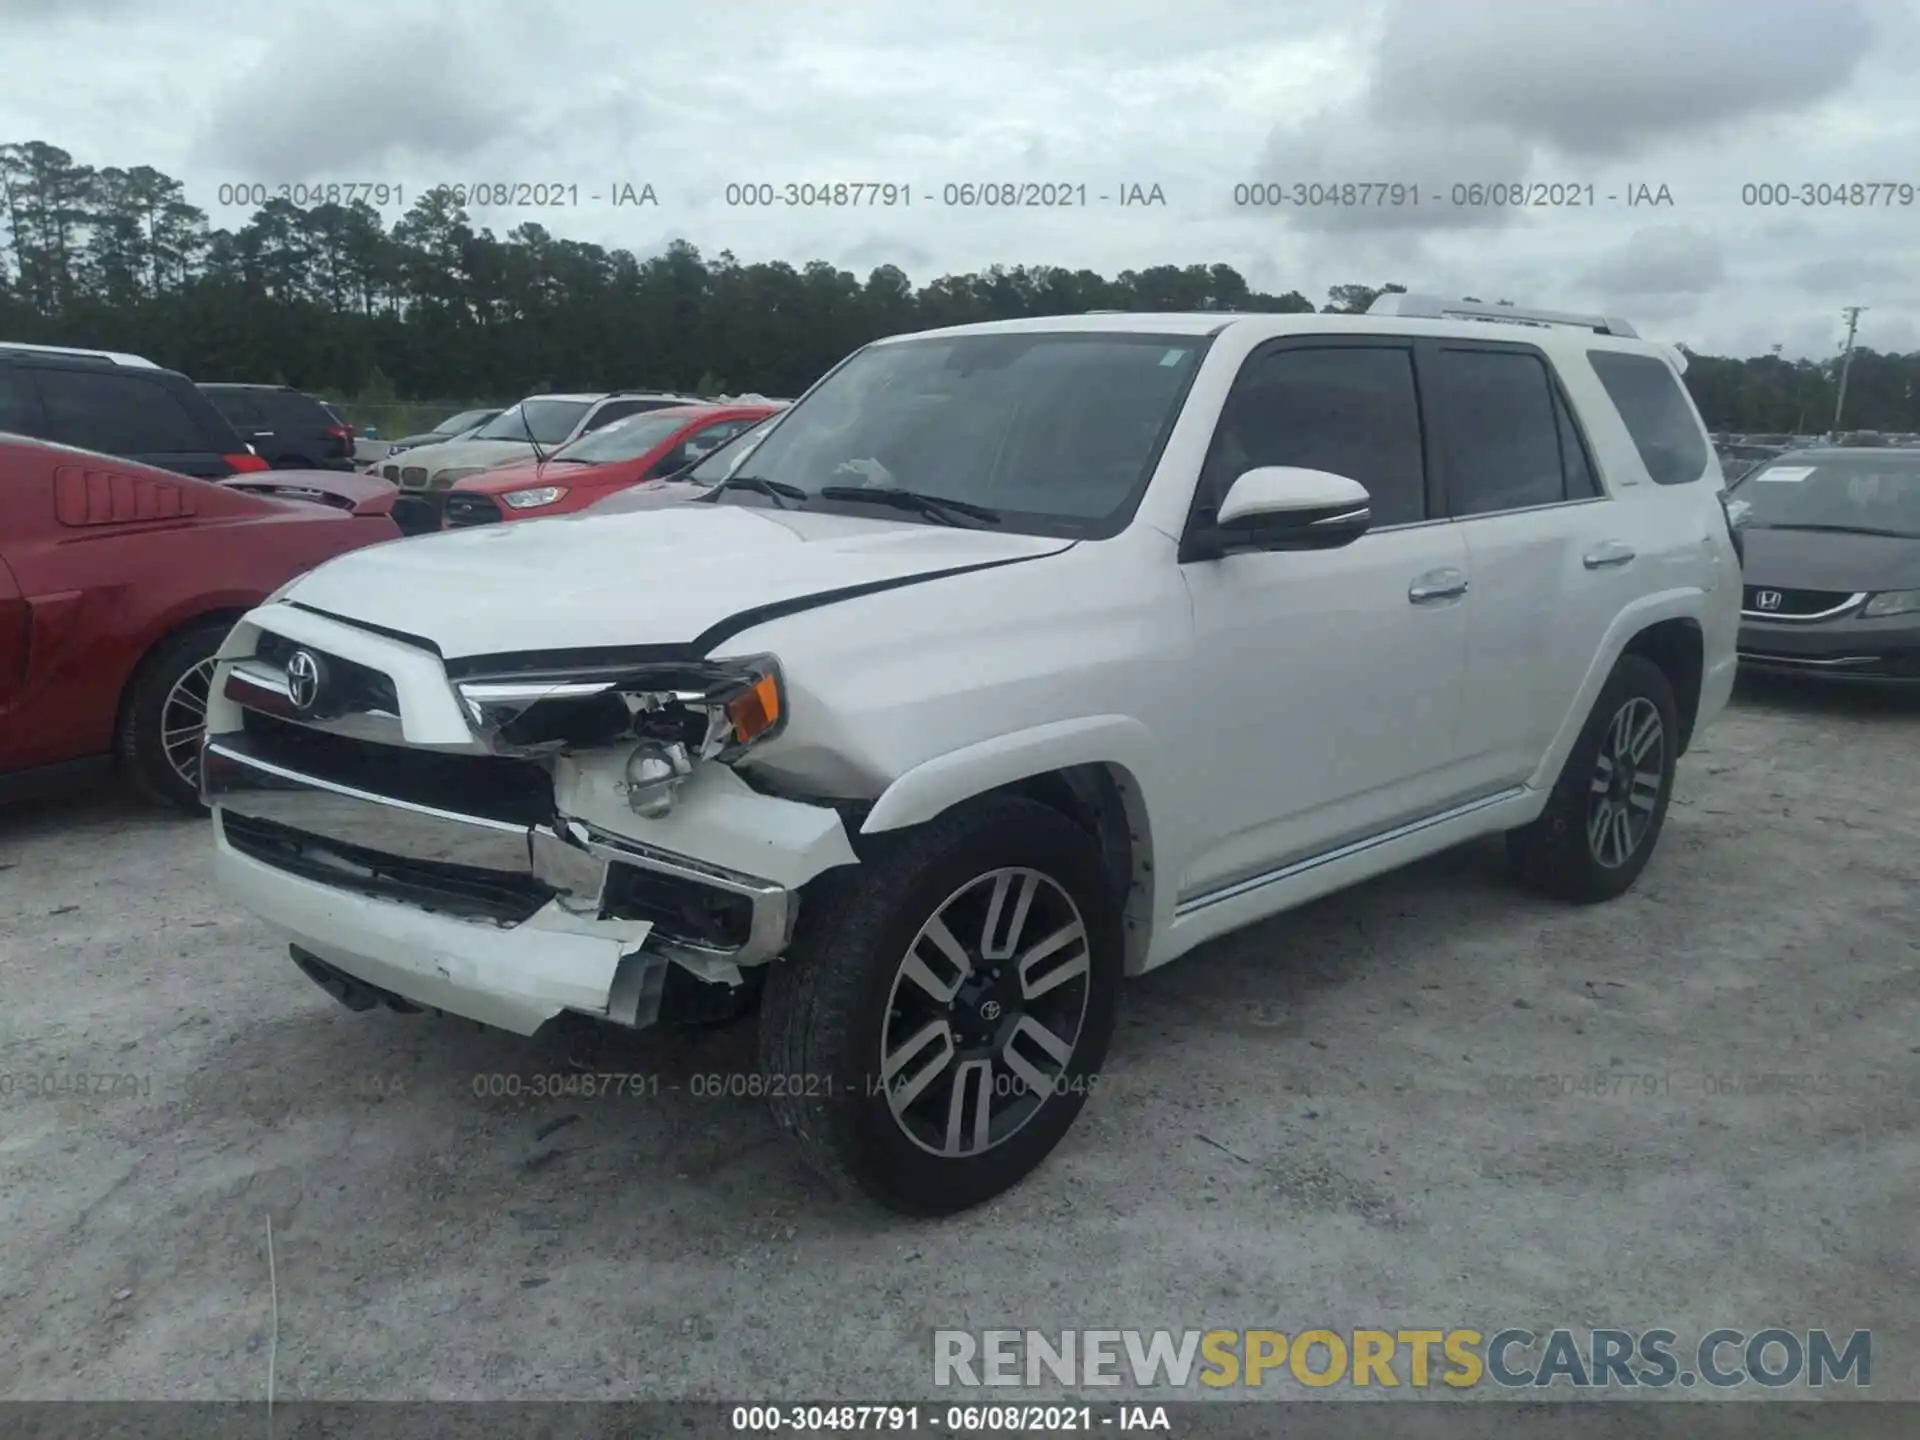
[0,340,267,480]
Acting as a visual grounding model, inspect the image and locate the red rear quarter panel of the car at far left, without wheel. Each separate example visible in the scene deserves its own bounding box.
[0,442,399,770]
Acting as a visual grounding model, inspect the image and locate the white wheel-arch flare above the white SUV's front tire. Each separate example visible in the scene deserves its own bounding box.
[860,714,1152,835]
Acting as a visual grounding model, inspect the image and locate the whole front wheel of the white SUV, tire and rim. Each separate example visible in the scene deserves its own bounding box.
[760,795,1123,1215]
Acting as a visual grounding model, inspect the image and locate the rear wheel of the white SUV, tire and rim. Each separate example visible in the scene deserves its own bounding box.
[1507,655,1680,904]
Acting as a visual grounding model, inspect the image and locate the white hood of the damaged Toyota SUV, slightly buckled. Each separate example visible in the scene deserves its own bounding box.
[284,503,1073,660]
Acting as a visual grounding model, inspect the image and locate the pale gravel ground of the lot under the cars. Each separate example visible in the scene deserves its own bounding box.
[0,685,1920,1400]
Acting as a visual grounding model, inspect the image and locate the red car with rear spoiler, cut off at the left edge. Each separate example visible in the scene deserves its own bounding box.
[0,434,399,810]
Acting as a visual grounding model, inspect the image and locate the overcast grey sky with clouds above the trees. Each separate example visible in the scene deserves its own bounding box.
[0,0,1920,357]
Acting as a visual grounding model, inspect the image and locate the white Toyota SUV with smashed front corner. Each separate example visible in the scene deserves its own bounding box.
[202,296,1741,1213]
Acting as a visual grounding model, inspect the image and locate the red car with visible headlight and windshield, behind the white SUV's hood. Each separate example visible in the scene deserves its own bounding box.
[440,405,781,530]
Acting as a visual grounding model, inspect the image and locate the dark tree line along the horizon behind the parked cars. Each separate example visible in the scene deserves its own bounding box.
[15,140,1920,434]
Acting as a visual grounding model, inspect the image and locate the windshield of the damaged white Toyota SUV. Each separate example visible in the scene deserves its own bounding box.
[691,332,1208,536]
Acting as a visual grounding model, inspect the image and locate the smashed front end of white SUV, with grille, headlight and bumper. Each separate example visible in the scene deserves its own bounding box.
[202,603,854,1035]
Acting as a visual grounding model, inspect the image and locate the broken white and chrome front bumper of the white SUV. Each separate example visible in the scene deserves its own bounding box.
[202,732,852,1035]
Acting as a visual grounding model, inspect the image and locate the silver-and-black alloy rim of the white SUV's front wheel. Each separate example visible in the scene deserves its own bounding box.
[879,868,1092,1158]
